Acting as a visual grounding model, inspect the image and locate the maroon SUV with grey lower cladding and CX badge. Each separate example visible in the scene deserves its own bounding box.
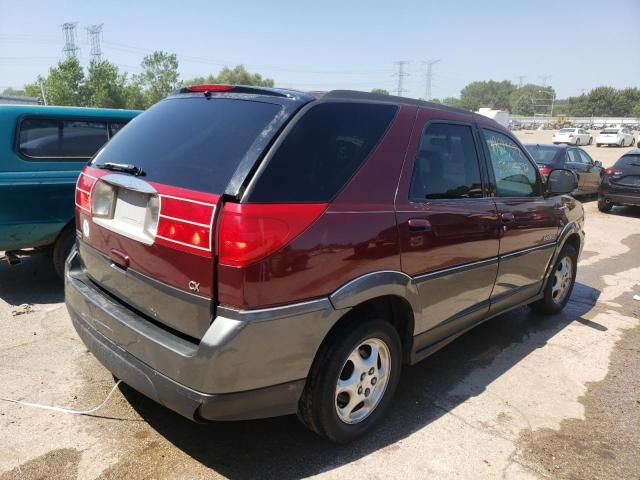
[66,85,584,442]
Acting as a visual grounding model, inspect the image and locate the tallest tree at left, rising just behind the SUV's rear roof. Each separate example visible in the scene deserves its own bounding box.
[134,51,180,107]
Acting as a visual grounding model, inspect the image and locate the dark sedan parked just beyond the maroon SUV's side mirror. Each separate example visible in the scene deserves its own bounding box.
[525,144,604,195]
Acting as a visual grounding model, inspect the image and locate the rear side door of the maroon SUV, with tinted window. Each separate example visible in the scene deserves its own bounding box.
[396,109,499,344]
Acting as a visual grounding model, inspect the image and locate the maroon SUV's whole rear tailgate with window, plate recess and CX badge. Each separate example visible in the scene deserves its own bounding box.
[76,96,292,341]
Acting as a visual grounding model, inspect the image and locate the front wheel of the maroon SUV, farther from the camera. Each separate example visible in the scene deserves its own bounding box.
[529,245,578,314]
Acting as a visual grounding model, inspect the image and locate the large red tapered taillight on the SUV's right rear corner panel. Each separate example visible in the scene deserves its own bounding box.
[218,203,327,267]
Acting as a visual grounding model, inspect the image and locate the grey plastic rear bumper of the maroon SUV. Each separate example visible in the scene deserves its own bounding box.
[65,249,344,420]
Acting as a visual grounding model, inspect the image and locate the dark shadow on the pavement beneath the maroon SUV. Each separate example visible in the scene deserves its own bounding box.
[121,283,607,479]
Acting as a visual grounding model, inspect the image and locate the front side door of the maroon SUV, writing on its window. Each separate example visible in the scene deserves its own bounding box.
[482,128,561,313]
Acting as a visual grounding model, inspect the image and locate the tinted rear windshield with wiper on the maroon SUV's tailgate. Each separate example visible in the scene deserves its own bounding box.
[93,97,281,193]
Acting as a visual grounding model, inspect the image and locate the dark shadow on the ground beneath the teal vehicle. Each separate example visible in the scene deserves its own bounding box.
[0,253,64,305]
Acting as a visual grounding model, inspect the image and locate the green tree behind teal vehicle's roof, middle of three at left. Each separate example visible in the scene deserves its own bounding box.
[84,60,127,108]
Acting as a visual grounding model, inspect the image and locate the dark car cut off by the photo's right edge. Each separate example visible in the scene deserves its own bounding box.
[598,149,640,212]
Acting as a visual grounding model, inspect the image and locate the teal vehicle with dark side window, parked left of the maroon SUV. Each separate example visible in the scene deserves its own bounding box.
[0,105,140,275]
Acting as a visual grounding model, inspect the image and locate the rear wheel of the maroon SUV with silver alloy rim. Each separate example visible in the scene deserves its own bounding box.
[298,319,402,443]
